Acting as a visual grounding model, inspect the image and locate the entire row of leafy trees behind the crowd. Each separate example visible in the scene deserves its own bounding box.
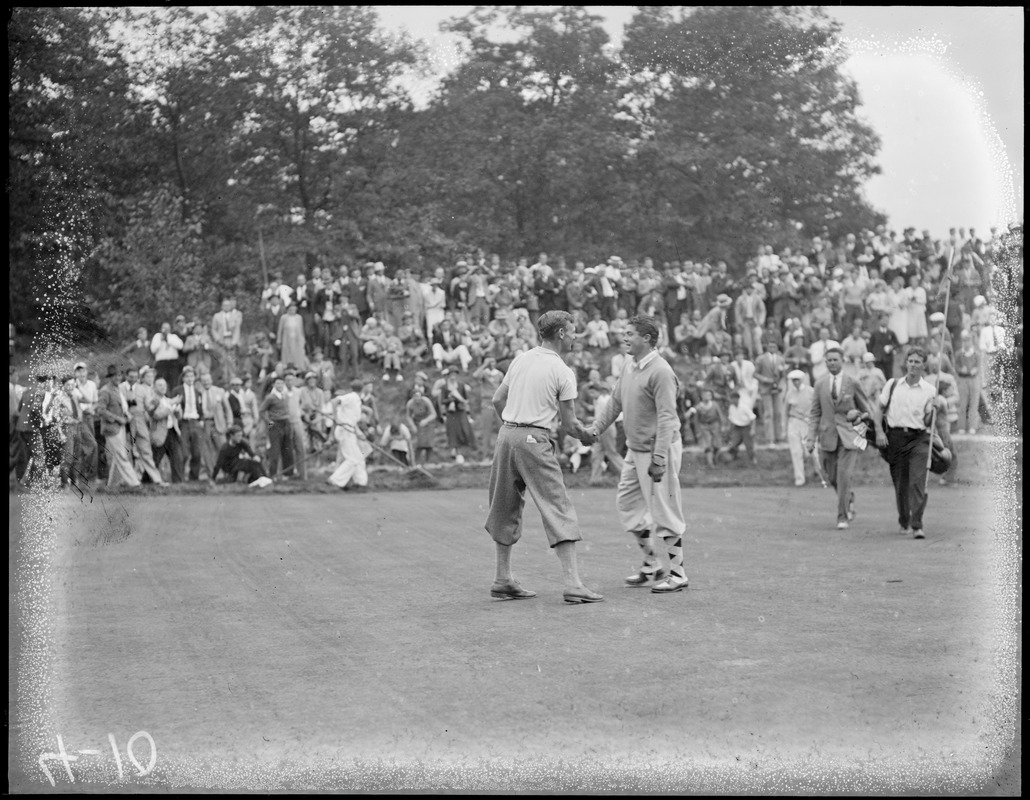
[7,6,883,343]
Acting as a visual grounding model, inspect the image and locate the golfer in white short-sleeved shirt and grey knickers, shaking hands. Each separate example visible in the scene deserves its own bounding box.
[486,311,605,603]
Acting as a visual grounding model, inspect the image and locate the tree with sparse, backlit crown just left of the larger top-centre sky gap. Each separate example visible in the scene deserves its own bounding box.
[214,6,419,268]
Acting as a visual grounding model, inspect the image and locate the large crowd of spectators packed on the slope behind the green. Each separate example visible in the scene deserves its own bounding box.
[11,221,1022,485]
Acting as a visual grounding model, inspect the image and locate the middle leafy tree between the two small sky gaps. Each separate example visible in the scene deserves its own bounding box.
[416,6,624,252]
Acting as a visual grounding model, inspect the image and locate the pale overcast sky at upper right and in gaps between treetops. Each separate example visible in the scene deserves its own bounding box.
[377,5,1024,236]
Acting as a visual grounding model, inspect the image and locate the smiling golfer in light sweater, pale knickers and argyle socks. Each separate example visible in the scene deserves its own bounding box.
[592,316,687,594]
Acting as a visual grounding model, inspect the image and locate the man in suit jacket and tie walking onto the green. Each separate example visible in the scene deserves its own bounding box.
[805,342,872,530]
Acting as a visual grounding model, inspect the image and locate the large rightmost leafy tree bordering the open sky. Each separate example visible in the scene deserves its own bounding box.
[623,6,879,257]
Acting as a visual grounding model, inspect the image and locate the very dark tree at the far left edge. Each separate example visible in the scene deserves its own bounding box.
[7,7,139,341]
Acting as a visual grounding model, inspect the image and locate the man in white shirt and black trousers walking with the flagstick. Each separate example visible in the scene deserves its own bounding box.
[874,347,937,538]
